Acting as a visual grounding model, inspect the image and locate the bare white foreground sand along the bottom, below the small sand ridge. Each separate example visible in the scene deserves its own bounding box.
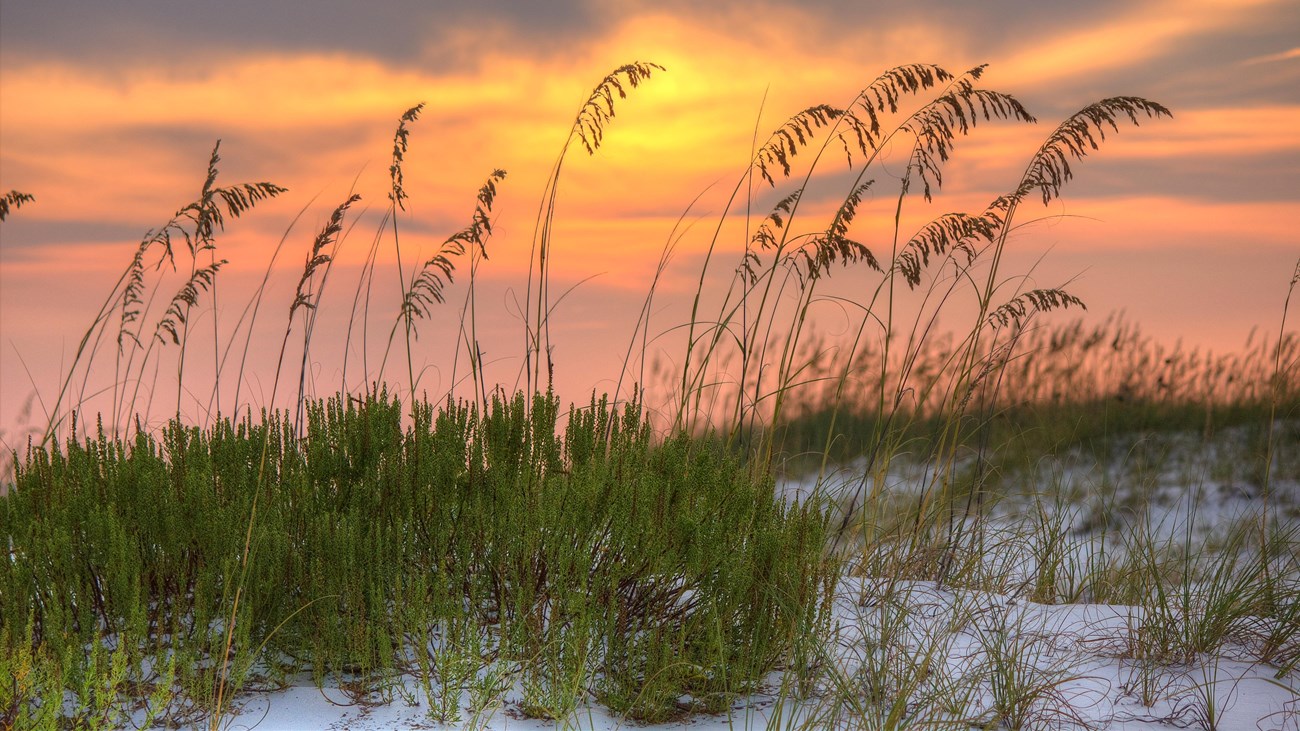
[188,578,1300,731]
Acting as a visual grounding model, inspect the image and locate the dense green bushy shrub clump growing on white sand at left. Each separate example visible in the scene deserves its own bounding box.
[0,392,837,724]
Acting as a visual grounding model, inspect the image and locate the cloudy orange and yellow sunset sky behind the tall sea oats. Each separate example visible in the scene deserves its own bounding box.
[0,0,1300,424]
